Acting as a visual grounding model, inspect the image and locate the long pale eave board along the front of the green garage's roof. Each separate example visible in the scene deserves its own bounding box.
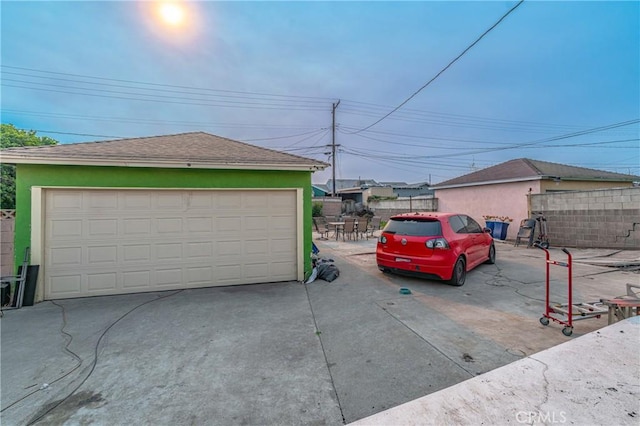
[2,154,328,171]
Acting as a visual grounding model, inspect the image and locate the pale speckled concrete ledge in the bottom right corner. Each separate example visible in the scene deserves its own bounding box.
[352,317,640,425]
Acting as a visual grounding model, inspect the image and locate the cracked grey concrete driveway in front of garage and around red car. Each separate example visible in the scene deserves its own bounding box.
[0,240,640,425]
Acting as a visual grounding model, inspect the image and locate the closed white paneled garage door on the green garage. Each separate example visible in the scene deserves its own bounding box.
[44,189,297,299]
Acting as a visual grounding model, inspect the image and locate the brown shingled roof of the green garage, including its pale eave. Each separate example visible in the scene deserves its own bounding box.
[2,132,329,171]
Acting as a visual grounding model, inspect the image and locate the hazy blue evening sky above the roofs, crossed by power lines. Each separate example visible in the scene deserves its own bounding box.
[0,1,640,183]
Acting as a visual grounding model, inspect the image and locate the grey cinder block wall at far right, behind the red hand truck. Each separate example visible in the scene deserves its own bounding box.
[531,187,640,249]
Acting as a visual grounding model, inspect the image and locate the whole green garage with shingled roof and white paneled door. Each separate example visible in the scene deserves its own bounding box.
[2,132,328,301]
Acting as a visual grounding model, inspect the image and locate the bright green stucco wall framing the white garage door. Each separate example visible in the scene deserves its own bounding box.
[14,164,312,277]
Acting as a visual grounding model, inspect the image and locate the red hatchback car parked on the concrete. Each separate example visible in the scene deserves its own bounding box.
[376,212,496,286]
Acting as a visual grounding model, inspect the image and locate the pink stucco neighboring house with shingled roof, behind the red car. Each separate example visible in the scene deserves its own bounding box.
[432,158,640,239]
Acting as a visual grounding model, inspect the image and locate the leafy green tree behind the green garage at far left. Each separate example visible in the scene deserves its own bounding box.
[0,124,58,209]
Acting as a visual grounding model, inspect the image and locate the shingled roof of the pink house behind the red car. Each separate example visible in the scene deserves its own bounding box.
[433,158,640,189]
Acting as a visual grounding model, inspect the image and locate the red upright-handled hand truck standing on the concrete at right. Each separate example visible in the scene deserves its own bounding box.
[534,243,608,336]
